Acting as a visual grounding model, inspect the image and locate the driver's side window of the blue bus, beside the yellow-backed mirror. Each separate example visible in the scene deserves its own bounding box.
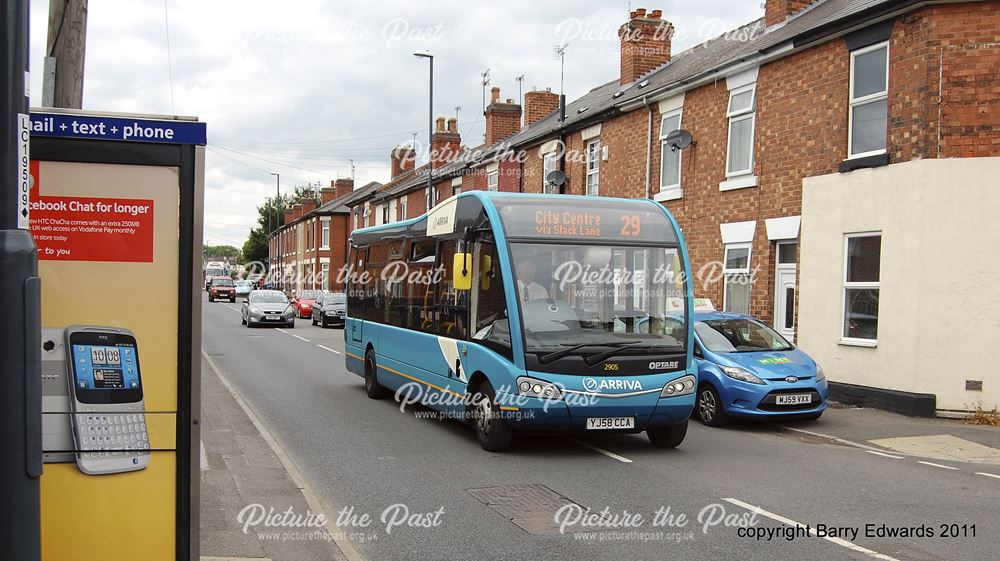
[472,242,512,358]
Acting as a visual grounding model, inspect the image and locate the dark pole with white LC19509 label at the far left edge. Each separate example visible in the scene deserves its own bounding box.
[0,0,42,561]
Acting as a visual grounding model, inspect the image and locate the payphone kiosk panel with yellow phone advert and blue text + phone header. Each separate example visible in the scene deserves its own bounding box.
[30,112,205,560]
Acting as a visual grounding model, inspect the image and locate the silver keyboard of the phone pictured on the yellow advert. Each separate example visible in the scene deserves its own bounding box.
[77,413,149,458]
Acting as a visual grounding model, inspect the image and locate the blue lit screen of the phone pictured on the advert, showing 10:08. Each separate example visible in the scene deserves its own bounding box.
[69,331,142,403]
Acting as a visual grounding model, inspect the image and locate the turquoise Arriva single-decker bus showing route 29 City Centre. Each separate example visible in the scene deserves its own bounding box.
[344,191,697,451]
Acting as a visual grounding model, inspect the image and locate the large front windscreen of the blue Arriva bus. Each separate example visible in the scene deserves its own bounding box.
[511,243,687,357]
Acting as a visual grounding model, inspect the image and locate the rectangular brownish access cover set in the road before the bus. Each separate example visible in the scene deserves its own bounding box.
[467,484,609,535]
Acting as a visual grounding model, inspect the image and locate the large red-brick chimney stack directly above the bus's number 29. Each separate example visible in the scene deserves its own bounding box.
[618,8,674,86]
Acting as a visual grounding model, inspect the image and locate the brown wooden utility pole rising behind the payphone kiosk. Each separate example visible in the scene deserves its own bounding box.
[42,0,87,109]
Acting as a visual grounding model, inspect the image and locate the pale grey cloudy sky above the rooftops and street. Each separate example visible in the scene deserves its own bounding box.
[31,0,763,247]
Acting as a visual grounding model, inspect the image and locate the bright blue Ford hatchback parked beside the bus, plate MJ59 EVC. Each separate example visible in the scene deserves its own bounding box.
[694,311,828,427]
